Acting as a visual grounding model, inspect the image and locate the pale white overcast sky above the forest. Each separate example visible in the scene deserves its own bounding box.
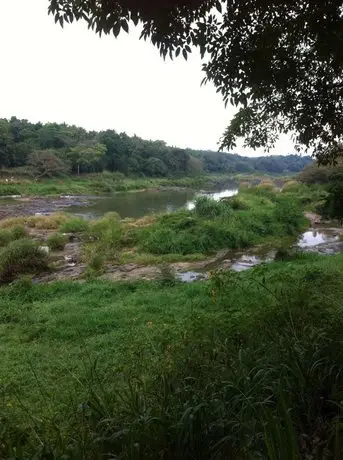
[0,0,294,156]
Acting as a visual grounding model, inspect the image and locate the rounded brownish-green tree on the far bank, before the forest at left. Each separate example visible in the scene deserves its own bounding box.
[28,150,70,179]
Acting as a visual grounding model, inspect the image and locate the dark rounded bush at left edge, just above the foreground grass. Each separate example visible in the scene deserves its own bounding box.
[0,239,48,282]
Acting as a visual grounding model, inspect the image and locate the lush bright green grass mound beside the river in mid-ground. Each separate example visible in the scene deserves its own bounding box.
[131,188,306,255]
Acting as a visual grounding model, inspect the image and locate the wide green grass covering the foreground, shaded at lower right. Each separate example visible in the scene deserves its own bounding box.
[0,255,343,460]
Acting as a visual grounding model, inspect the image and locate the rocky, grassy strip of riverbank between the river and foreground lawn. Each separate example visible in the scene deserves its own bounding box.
[0,186,313,282]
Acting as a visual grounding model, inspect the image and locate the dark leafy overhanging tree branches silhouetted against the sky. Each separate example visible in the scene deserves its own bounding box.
[49,0,343,163]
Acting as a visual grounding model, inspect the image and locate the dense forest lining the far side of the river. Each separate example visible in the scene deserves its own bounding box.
[0,117,312,177]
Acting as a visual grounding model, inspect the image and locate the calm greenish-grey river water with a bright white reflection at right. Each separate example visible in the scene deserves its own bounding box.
[66,185,238,219]
